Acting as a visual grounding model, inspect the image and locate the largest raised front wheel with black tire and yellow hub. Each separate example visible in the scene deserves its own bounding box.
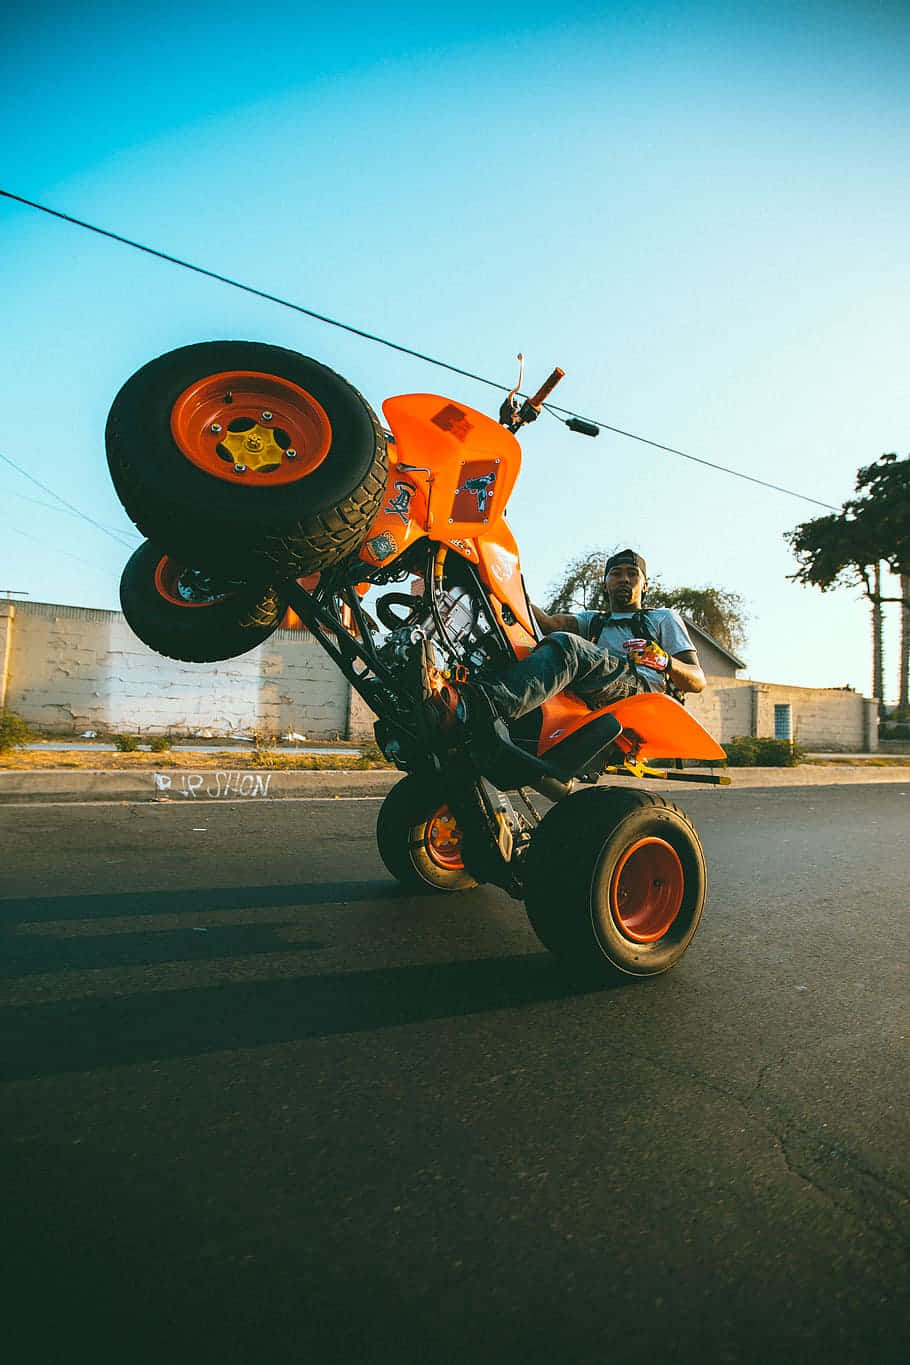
[105,341,387,580]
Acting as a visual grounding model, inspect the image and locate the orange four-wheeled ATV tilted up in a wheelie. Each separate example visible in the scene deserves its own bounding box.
[106,341,724,976]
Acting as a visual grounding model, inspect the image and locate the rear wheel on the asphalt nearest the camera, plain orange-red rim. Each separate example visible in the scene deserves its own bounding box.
[523,788,707,979]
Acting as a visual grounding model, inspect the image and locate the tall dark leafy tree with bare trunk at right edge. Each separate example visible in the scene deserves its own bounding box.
[786,450,910,704]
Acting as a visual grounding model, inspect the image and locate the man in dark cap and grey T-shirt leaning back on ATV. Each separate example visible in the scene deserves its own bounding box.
[424,549,705,729]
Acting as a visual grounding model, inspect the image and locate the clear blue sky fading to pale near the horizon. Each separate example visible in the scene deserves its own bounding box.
[0,0,910,696]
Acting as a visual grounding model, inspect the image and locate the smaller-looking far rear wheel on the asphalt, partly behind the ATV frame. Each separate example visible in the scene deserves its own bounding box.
[377,777,479,893]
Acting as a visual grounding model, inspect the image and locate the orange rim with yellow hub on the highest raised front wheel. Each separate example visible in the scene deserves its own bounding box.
[171,370,332,487]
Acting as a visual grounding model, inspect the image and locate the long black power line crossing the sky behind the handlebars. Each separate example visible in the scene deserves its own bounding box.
[0,190,839,513]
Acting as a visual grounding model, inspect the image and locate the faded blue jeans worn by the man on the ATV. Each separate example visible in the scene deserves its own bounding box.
[483,631,644,721]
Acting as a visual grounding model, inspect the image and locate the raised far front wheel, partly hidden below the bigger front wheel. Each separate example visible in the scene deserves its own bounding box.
[120,541,287,663]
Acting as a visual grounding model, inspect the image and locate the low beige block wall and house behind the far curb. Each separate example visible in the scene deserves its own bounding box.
[0,602,879,752]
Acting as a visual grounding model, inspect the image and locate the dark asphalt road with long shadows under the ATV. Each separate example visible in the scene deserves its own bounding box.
[0,785,910,1365]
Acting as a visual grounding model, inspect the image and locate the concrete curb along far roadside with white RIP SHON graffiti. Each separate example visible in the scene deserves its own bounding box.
[0,763,910,805]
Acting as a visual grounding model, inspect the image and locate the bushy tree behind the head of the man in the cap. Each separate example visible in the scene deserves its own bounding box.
[544,550,746,651]
